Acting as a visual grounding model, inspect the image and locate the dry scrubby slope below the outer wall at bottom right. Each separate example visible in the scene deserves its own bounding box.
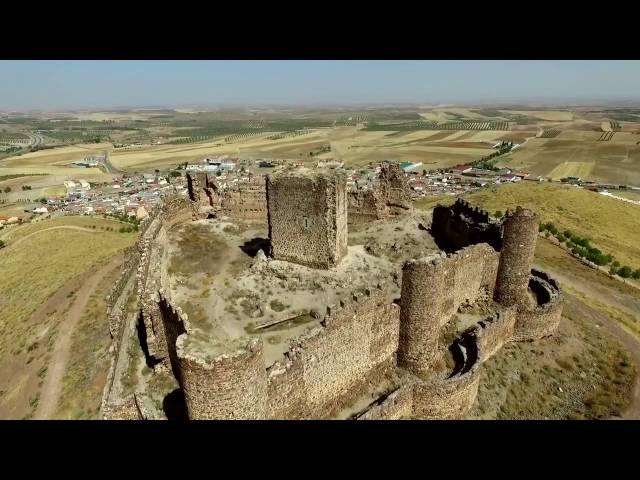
[469,300,637,419]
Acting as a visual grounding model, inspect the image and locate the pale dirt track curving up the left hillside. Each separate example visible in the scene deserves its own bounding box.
[33,256,122,420]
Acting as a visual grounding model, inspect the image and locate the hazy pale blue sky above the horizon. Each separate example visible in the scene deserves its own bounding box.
[0,60,640,110]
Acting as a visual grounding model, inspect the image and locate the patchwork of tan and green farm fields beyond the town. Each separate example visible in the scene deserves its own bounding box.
[0,106,640,185]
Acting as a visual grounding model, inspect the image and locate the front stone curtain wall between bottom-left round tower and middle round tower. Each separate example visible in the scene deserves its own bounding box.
[268,287,399,418]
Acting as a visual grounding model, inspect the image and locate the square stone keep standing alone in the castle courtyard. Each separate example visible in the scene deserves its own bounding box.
[267,172,347,269]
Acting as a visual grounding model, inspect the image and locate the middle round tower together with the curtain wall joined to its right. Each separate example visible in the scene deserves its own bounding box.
[398,244,498,375]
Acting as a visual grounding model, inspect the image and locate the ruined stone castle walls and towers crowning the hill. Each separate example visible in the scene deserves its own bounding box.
[103,166,562,419]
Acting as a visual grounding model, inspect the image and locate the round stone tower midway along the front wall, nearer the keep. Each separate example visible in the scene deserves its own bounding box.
[398,259,451,375]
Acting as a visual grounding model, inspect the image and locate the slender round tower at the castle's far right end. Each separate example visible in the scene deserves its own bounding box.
[494,207,539,307]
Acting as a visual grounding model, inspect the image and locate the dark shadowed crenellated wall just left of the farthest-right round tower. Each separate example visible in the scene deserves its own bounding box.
[431,198,502,252]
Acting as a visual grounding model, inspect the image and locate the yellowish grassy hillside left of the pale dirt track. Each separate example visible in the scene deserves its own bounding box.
[0,217,136,418]
